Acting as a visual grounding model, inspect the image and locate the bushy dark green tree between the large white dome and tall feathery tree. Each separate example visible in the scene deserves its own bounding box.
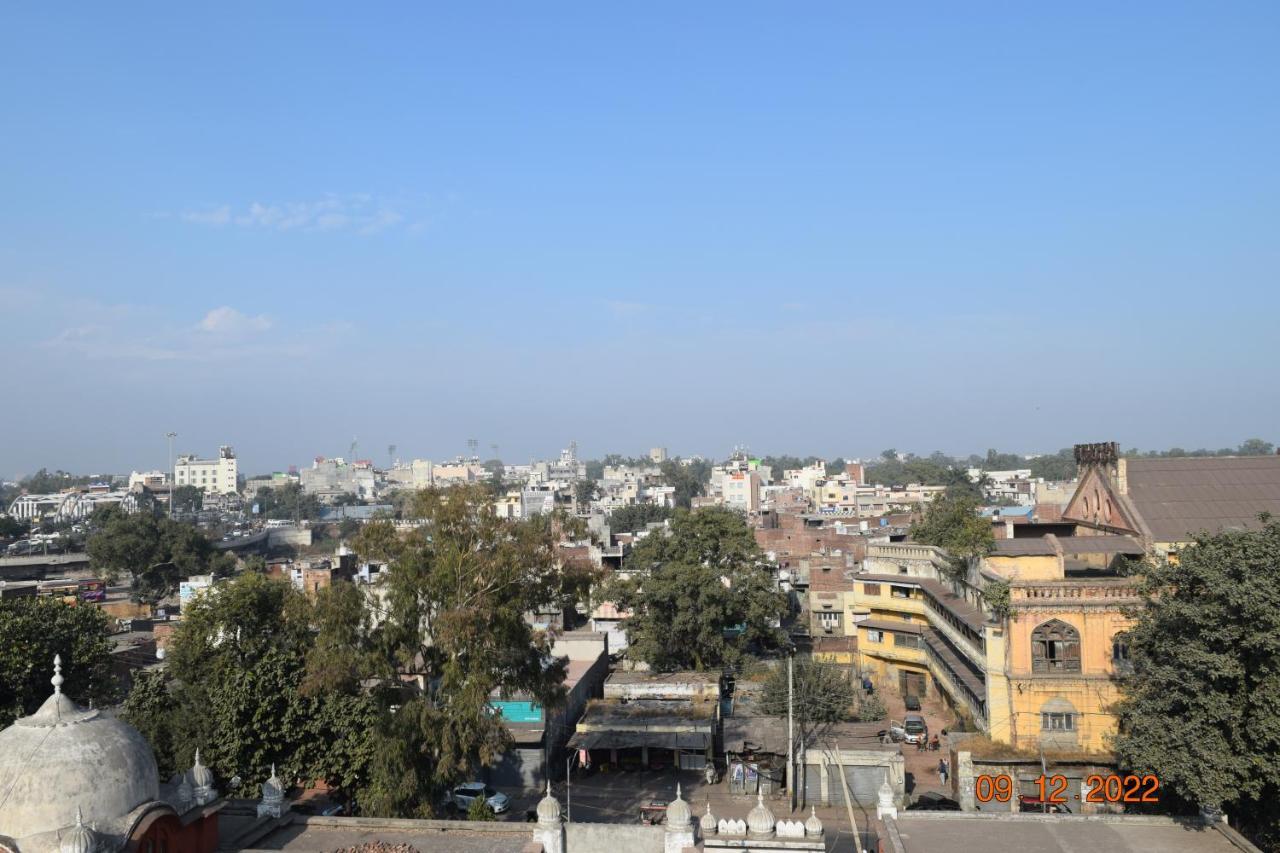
[124,573,379,798]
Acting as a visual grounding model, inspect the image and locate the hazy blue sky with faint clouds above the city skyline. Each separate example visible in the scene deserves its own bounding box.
[0,1,1280,476]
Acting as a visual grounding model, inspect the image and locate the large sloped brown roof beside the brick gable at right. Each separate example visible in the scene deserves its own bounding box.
[1128,456,1280,542]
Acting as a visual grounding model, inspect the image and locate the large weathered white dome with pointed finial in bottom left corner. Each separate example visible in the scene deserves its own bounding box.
[0,665,160,839]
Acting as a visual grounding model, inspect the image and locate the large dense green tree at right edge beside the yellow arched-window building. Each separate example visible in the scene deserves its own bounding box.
[1114,516,1280,850]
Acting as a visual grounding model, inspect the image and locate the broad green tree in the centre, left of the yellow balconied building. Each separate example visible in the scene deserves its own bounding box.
[604,507,787,671]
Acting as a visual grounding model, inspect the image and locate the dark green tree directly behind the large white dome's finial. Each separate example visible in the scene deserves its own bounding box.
[0,597,119,729]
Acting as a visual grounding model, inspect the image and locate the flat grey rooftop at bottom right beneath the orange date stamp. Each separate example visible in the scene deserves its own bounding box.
[886,812,1248,853]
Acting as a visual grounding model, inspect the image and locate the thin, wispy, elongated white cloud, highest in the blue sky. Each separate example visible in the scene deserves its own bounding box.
[178,193,406,234]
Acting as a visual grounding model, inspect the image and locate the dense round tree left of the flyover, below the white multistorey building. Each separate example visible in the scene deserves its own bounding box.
[86,506,236,603]
